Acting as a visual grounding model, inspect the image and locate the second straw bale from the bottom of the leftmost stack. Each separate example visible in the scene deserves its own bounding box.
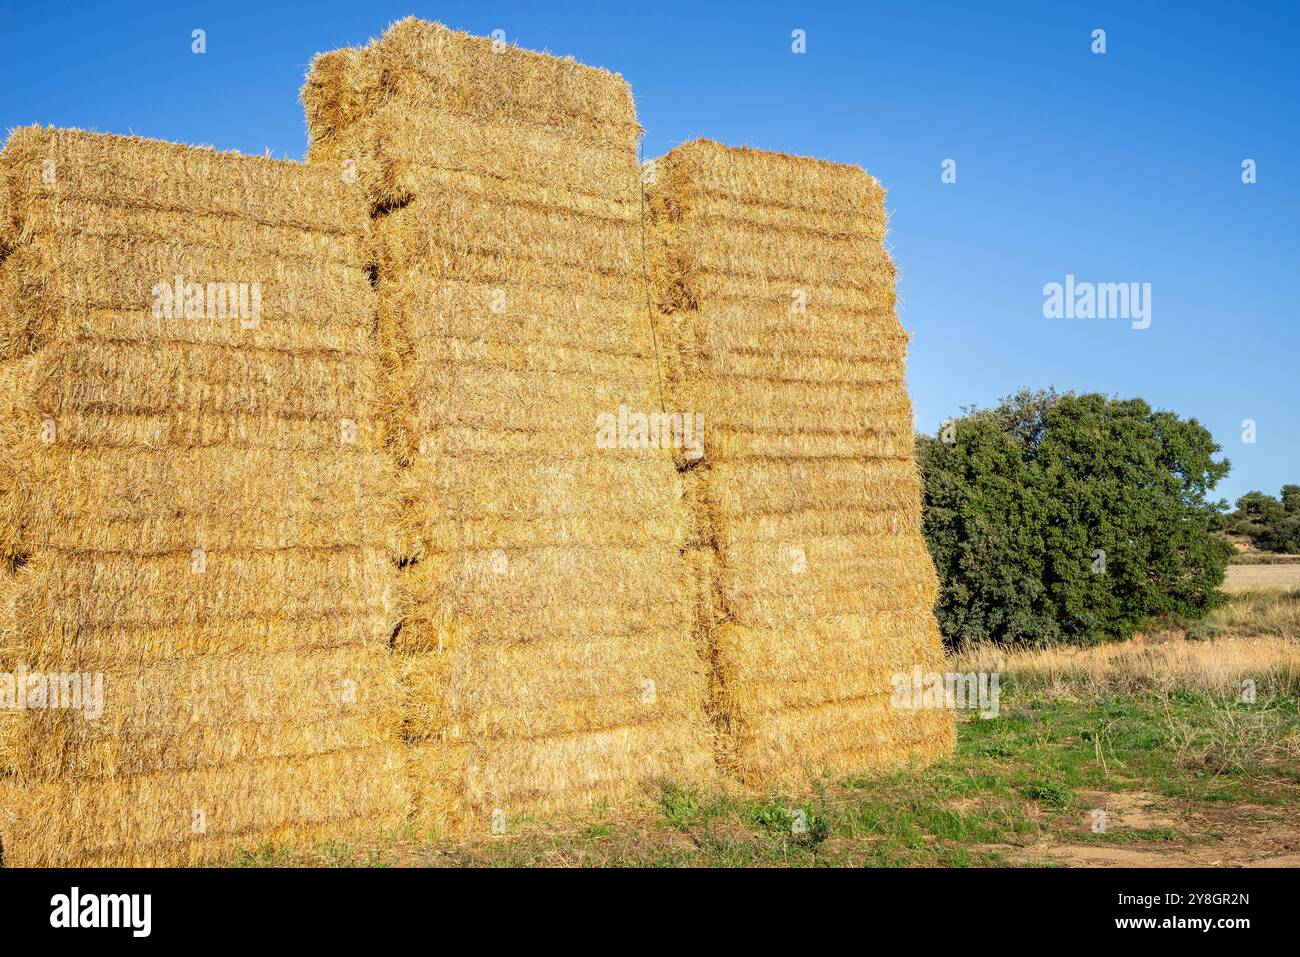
[20,646,399,781]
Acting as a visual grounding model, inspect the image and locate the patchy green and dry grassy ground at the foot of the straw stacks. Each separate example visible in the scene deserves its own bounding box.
[239,590,1300,866]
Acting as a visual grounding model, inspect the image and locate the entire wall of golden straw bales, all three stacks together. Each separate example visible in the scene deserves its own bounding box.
[0,27,953,865]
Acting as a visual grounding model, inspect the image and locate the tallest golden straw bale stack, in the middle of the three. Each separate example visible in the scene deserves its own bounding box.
[303,20,712,830]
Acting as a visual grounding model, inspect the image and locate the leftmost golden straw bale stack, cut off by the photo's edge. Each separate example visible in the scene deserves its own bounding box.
[0,127,407,865]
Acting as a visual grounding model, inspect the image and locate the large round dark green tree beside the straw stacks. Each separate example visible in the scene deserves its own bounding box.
[918,390,1231,644]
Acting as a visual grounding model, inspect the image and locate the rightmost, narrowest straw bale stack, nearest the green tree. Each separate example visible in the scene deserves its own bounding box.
[650,140,953,783]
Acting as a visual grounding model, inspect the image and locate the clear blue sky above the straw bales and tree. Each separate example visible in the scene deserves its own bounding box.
[0,0,1300,498]
